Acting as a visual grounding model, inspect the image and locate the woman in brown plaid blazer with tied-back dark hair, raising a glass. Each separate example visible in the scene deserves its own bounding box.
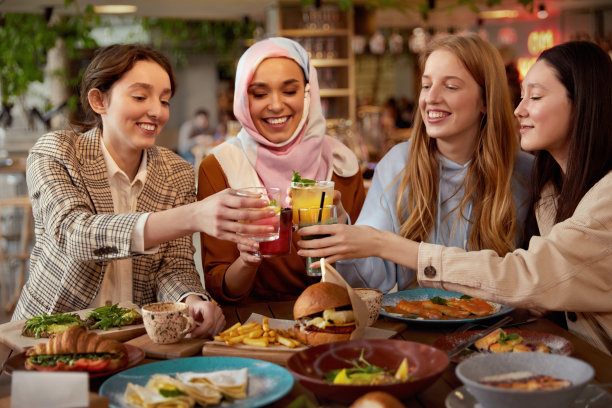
[12,45,270,336]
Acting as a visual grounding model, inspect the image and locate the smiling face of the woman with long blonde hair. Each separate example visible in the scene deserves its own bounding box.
[419,49,486,158]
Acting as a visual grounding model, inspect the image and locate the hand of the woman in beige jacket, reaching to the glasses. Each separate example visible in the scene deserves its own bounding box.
[297,224,380,267]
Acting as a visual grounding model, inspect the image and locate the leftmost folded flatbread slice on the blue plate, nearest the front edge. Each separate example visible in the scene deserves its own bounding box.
[123,383,195,408]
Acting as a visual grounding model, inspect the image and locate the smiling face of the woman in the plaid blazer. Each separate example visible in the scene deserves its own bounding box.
[93,60,172,155]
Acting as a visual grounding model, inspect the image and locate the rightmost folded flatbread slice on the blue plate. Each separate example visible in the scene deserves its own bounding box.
[176,368,249,399]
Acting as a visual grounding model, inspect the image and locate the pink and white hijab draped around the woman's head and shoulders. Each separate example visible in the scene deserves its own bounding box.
[231,37,359,198]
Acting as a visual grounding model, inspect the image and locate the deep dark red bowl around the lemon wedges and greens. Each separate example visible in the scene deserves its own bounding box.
[287,339,449,404]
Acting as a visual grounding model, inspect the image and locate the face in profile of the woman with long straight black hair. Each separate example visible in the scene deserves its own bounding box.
[514,60,572,172]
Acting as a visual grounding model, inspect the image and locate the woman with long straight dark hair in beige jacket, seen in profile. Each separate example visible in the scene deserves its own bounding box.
[301,42,612,354]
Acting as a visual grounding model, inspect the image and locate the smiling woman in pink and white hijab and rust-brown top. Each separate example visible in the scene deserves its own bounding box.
[198,37,365,302]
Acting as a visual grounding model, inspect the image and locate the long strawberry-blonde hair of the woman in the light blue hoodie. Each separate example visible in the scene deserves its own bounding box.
[396,34,518,255]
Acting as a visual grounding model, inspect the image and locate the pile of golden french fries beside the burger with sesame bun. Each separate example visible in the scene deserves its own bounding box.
[212,313,306,350]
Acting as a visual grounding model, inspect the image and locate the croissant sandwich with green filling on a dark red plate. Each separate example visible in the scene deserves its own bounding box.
[25,326,128,372]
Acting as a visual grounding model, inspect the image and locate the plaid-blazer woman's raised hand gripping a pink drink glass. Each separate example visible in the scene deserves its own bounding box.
[194,189,275,247]
